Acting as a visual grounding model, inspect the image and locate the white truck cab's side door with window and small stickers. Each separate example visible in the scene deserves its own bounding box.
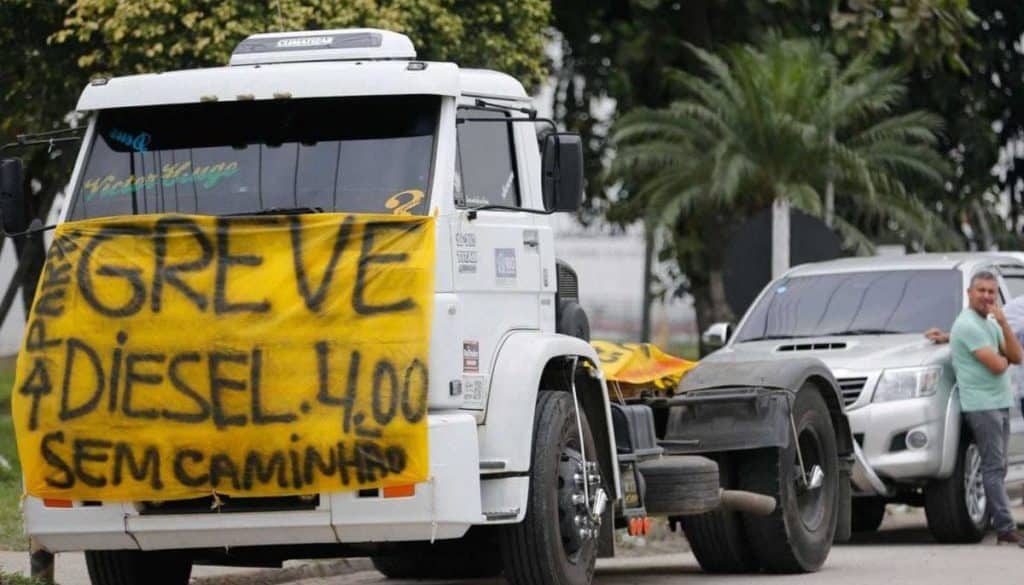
[451,108,542,411]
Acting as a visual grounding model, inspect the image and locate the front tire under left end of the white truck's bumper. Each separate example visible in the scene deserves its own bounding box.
[85,550,193,585]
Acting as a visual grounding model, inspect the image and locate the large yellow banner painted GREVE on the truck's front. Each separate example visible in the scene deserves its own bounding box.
[12,213,434,501]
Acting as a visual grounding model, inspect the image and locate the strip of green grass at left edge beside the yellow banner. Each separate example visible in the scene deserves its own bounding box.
[0,358,25,553]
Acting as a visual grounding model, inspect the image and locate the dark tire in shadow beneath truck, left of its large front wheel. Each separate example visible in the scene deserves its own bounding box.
[371,527,502,579]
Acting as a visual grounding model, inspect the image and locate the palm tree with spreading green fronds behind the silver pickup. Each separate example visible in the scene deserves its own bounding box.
[610,35,958,352]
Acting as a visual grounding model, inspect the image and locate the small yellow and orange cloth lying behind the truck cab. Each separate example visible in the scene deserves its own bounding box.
[590,341,697,390]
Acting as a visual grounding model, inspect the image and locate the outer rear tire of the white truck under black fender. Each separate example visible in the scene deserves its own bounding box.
[739,384,840,573]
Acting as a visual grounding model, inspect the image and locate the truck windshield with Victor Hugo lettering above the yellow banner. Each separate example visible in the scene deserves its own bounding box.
[69,95,440,219]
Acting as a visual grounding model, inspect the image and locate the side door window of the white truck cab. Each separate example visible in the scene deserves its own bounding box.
[455,108,519,207]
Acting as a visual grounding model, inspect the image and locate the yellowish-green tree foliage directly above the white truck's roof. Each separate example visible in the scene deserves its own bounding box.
[51,0,550,87]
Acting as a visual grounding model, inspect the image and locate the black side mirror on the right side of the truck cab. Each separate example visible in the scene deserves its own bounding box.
[541,132,583,211]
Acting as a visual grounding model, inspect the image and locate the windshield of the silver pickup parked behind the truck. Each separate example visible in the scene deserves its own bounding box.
[736,269,964,342]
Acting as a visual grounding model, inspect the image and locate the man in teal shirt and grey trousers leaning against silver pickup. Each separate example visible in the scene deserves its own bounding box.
[949,270,1024,546]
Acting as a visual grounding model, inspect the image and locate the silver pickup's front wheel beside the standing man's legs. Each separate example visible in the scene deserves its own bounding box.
[925,436,988,543]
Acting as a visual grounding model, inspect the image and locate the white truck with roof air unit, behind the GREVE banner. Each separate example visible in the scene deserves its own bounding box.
[0,29,848,585]
